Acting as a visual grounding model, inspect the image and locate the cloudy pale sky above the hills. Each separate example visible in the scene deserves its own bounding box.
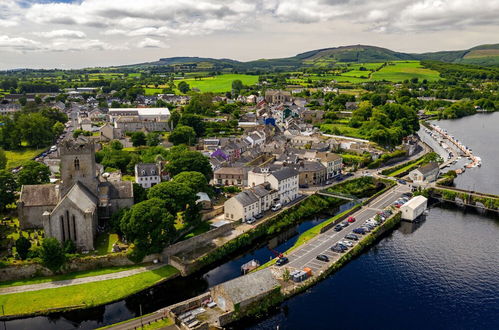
[0,0,499,69]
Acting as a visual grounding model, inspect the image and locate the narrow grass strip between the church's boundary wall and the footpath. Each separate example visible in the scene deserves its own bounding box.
[0,264,148,288]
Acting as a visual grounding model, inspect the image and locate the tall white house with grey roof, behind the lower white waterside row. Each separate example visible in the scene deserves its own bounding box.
[248,167,299,204]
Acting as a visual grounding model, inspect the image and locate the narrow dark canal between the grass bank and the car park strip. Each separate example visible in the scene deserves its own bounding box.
[5,203,354,330]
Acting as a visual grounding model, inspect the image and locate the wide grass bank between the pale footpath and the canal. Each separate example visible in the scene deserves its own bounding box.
[0,265,178,315]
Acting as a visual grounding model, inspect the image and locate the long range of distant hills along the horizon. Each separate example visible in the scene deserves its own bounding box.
[126,44,499,71]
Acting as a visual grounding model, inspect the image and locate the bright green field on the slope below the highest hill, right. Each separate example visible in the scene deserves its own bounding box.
[371,61,440,82]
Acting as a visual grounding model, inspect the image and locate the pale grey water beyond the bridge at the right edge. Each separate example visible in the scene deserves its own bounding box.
[433,112,499,194]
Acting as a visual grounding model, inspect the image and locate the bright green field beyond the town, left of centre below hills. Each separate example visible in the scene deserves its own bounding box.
[176,74,258,93]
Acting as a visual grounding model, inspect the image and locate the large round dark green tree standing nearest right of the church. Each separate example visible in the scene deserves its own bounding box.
[120,198,175,253]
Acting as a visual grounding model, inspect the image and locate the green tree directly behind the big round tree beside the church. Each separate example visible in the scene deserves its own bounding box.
[147,181,197,214]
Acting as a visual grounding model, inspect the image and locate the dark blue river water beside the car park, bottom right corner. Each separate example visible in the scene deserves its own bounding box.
[238,208,499,329]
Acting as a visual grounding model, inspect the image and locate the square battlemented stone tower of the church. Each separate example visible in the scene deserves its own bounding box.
[59,138,99,196]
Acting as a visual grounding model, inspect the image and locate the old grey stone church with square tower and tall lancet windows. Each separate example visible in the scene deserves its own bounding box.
[18,137,133,251]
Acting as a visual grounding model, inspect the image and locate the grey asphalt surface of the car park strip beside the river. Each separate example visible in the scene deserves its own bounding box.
[286,185,410,274]
